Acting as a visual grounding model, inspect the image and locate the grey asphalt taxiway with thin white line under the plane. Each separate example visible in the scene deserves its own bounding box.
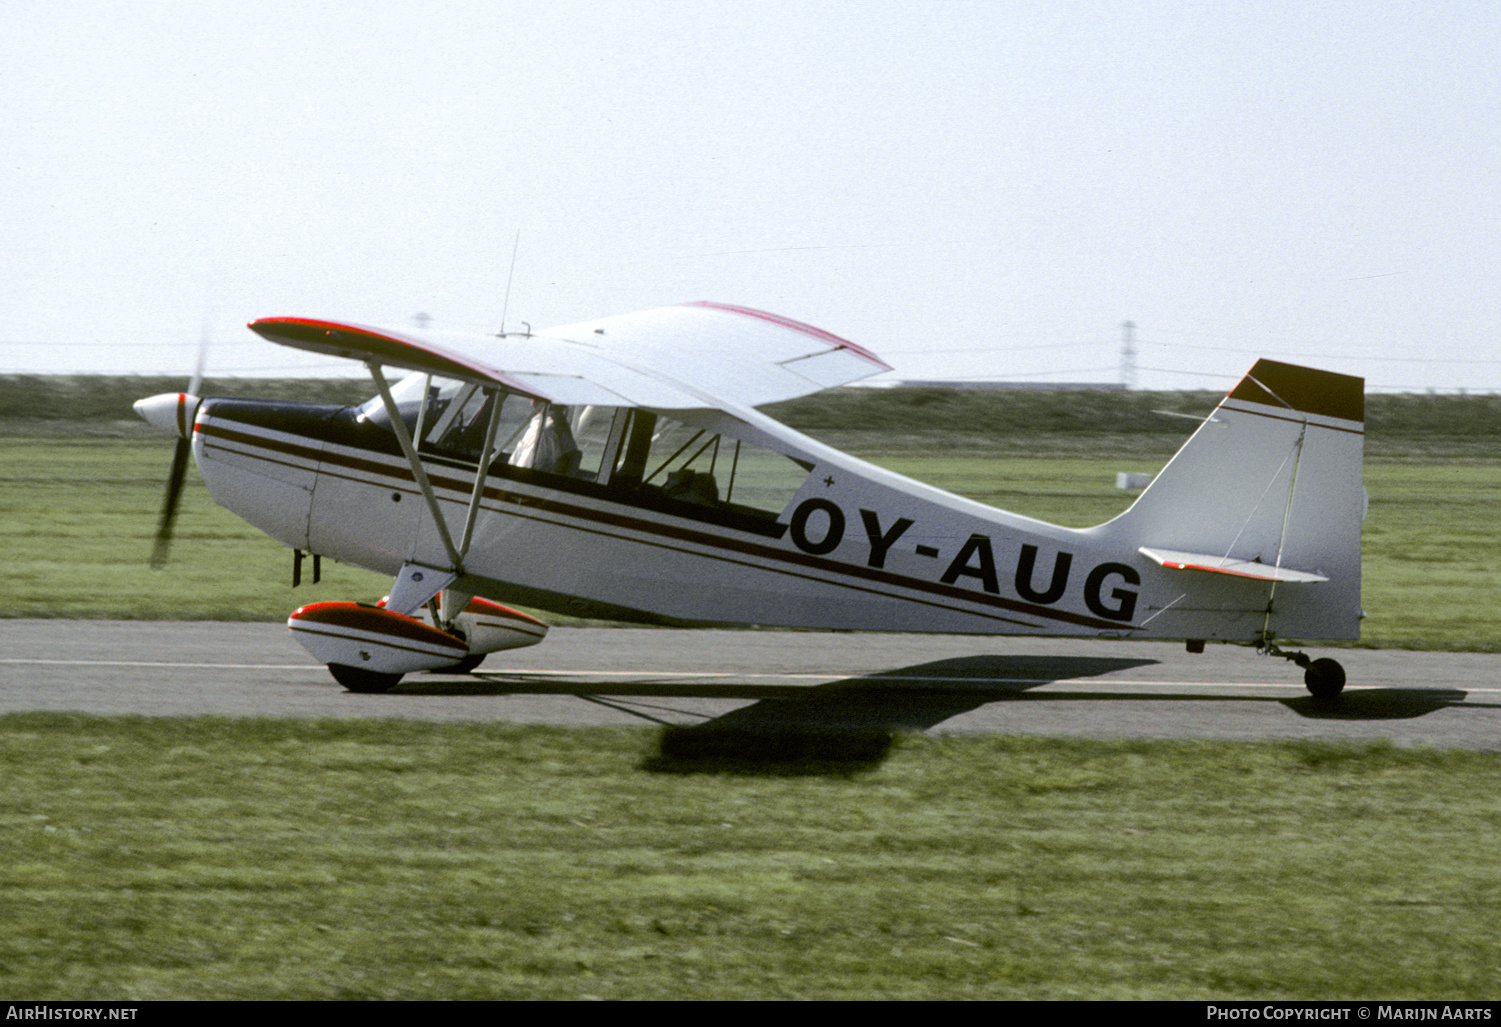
[0,620,1501,749]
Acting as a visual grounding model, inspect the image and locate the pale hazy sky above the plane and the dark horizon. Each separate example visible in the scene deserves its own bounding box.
[0,0,1501,390]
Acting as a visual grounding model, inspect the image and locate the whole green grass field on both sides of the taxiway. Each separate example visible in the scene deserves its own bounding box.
[0,383,1501,1001]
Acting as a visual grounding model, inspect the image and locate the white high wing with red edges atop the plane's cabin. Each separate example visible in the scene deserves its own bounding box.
[249,302,892,410]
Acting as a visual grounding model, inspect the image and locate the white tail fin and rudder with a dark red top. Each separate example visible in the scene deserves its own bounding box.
[1097,360,1366,638]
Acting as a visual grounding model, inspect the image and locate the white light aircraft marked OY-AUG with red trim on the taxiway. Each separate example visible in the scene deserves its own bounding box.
[135,302,1364,698]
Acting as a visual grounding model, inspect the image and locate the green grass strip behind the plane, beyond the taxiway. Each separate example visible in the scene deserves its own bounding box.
[0,435,1501,652]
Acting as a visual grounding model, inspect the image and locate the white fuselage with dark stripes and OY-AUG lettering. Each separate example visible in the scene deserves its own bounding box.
[181,375,1358,641]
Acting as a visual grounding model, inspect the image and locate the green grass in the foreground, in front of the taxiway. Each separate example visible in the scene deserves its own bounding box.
[0,713,1501,1000]
